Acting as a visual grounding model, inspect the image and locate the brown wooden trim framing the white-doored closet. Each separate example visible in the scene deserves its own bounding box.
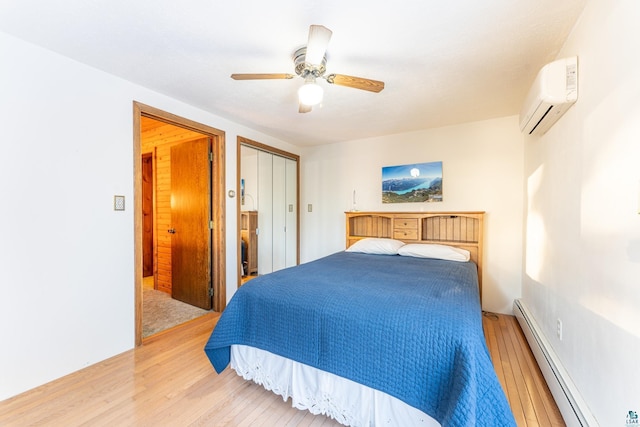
[236,136,300,288]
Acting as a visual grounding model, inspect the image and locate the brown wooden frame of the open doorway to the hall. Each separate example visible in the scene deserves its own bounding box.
[133,101,227,346]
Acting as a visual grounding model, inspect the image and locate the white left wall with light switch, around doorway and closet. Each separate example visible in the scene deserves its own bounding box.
[0,33,298,400]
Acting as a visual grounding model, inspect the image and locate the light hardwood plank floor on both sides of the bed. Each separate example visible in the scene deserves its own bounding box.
[0,313,564,426]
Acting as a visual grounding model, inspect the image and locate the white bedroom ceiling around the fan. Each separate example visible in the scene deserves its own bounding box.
[0,0,586,145]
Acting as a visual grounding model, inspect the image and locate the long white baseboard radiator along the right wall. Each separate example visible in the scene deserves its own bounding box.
[513,299,598,427]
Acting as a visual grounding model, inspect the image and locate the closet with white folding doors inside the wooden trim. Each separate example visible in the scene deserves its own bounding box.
[238,138,299,274]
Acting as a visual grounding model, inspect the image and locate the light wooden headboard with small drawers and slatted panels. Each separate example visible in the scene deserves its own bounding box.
[345,212,484,299]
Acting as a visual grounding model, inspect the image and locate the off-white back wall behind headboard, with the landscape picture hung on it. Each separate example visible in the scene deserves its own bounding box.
[301,116,524,313]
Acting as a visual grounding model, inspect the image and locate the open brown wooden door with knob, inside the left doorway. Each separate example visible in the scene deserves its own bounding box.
[168,138,212,310]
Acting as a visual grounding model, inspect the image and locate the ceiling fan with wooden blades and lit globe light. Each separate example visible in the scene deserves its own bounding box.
[231,25,384,113]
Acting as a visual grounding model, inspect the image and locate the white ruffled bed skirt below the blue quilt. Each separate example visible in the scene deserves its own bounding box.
[231,345,440,427]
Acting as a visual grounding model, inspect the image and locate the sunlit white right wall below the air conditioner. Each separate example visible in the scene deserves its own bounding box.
[523,0,640,426]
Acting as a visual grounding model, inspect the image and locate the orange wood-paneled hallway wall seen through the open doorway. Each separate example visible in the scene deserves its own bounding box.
[140,117,208,294]
